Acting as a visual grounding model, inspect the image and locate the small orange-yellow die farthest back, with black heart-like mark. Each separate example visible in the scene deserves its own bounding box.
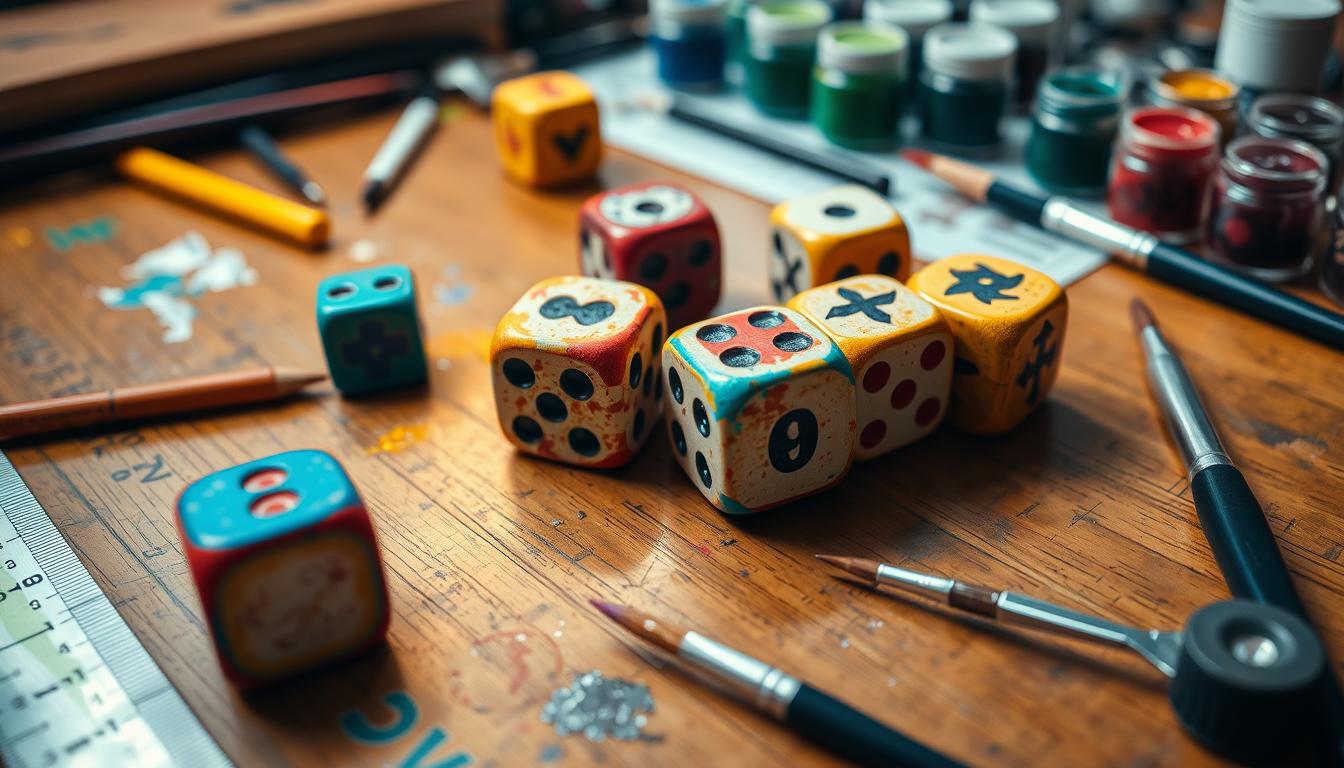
[491,71,602,187]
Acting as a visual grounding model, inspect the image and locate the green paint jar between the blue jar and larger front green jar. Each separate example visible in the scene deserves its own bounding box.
[745,0,831,117]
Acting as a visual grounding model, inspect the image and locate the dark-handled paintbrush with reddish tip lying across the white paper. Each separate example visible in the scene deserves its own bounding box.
[900,149,1344,350]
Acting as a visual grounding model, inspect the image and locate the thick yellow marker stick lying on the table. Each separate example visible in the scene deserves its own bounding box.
[117,147,331,247]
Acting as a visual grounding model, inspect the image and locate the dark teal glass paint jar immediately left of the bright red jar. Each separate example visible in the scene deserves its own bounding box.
[1025,67,1129,195]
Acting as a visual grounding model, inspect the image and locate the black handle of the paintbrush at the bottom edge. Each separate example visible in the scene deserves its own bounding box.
[785,685,961,768]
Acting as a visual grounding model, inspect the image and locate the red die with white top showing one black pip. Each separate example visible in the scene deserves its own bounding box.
[579,182,723,328]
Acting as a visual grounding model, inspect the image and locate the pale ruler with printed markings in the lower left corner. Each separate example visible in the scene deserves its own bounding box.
[0,453,230,768]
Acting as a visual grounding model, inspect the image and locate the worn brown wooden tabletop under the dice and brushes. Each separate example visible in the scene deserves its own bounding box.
[0,103,1344,767]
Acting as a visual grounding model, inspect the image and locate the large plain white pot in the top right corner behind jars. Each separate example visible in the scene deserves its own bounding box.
[1214,0,1340,93]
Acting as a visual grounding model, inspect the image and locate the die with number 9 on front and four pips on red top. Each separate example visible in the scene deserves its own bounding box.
[663,307,855,514]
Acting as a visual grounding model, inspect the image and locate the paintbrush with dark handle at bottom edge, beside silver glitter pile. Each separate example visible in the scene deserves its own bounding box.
[590,600,960,767]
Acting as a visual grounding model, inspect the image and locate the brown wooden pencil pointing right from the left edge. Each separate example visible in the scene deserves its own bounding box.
[0,367,327,440]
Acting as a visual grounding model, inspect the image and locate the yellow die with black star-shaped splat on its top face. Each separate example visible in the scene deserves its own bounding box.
[910,253,1068,434]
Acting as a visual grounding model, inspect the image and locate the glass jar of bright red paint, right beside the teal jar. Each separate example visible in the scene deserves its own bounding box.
[1106,106,1220,243]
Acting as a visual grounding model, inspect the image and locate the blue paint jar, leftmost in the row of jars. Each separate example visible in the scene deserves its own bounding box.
[649,0,727,89]
